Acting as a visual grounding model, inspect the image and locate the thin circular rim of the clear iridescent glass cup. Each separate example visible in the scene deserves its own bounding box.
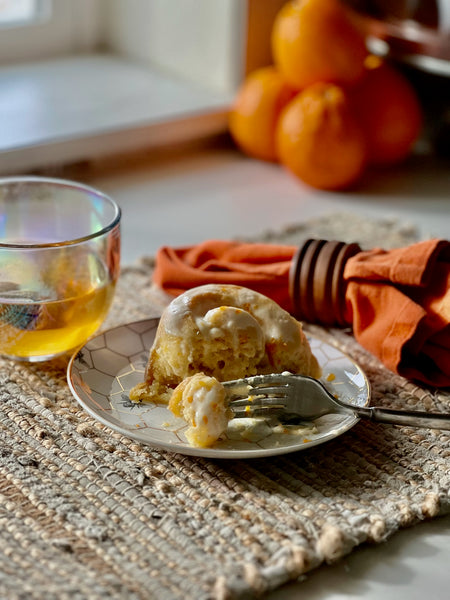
[0,175,122,249]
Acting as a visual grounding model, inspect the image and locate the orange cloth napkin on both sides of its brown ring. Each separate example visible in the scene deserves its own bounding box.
[154,240,450,387]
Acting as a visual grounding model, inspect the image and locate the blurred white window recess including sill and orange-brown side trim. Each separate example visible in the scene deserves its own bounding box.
[0,0,285,175]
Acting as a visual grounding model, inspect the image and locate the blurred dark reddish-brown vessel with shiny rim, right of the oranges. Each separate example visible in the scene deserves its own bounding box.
[345,0,450,157]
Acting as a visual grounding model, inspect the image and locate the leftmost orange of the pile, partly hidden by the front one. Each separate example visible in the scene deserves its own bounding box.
[228,67,296,161]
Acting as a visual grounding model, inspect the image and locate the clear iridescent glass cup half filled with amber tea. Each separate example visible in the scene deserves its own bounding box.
[0,177,121,362]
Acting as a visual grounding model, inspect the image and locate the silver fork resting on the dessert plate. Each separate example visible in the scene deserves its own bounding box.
[223,374,450,429]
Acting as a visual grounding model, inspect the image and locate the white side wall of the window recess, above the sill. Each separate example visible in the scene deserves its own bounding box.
[103,0,247,91]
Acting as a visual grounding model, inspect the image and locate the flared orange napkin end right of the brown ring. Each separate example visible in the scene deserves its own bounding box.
[344,240,450,387]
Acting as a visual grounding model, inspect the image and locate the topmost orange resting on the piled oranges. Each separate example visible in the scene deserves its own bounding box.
[271,0,367,89]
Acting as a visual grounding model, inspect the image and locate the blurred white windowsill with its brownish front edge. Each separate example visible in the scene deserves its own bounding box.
[0,54,233,175]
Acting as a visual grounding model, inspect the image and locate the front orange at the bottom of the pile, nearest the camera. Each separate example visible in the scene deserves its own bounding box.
[277,83,366,190]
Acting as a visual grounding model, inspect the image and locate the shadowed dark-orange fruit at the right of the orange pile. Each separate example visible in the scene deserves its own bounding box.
[351,56,423,165]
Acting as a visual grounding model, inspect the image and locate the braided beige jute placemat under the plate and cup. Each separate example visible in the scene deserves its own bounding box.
[0,215,450,600]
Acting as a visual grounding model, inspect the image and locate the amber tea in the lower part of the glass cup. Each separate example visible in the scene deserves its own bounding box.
[0,250,115,360]
